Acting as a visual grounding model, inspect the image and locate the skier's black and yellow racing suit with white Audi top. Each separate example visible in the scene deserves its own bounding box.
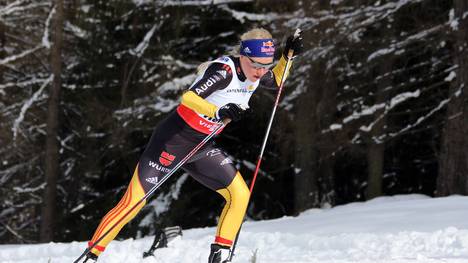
[89,54,292,255]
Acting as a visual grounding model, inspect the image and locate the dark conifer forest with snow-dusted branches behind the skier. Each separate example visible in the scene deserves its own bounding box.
[0,0,468,243]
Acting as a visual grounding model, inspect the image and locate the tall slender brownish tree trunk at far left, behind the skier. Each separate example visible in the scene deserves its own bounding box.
[40,0,63,242]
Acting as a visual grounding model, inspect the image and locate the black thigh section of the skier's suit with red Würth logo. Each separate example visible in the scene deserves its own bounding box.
[138,112,237,192]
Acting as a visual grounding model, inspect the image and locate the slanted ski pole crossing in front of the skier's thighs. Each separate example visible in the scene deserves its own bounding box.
[73,119,231,263]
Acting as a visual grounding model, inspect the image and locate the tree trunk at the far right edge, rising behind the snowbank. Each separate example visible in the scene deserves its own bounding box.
[437,0,468,196]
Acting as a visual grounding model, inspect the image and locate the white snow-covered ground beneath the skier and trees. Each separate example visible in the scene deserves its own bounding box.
[0,195,468,263]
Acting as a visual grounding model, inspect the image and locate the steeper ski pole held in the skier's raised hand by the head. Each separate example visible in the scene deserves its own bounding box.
[223,28,301,263]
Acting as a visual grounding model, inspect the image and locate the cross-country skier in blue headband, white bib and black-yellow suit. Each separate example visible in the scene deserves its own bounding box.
[84,28,302,263]
